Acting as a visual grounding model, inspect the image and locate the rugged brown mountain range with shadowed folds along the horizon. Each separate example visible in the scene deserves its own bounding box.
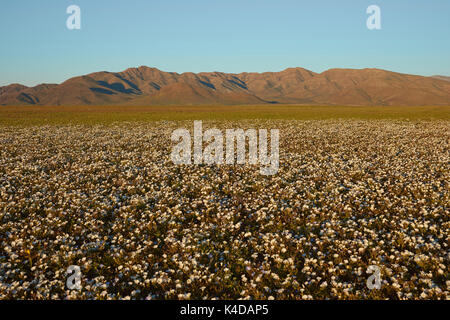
[0,67,450,105]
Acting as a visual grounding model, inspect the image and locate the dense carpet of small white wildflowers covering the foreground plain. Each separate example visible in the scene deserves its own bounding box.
[0,119,450,299]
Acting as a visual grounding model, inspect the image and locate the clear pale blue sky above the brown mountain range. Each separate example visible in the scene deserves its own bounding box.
[0,0,450,86]
